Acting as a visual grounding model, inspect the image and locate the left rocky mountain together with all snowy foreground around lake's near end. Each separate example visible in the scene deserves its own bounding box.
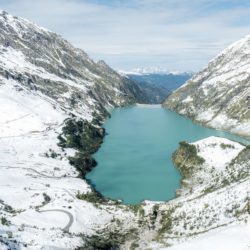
[0,8,250,250]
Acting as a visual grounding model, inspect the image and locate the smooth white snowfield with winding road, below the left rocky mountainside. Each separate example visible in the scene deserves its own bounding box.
[0,73,139,249]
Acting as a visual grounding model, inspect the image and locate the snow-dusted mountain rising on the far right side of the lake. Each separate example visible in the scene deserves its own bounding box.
[164,35,250,137]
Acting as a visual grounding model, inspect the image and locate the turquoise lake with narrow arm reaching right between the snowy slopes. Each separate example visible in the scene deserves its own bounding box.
[87,105,248,204]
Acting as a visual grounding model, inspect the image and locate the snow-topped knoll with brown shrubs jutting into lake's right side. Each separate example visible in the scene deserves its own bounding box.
[172,137,250,195]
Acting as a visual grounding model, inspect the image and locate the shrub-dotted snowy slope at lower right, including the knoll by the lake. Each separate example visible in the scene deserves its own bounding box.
[138,137,250,250]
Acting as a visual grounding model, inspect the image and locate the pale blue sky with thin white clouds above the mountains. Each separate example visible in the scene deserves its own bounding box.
[0,0,250,71]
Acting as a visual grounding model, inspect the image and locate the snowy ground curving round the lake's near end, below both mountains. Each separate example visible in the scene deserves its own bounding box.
[0,70,250,250]
